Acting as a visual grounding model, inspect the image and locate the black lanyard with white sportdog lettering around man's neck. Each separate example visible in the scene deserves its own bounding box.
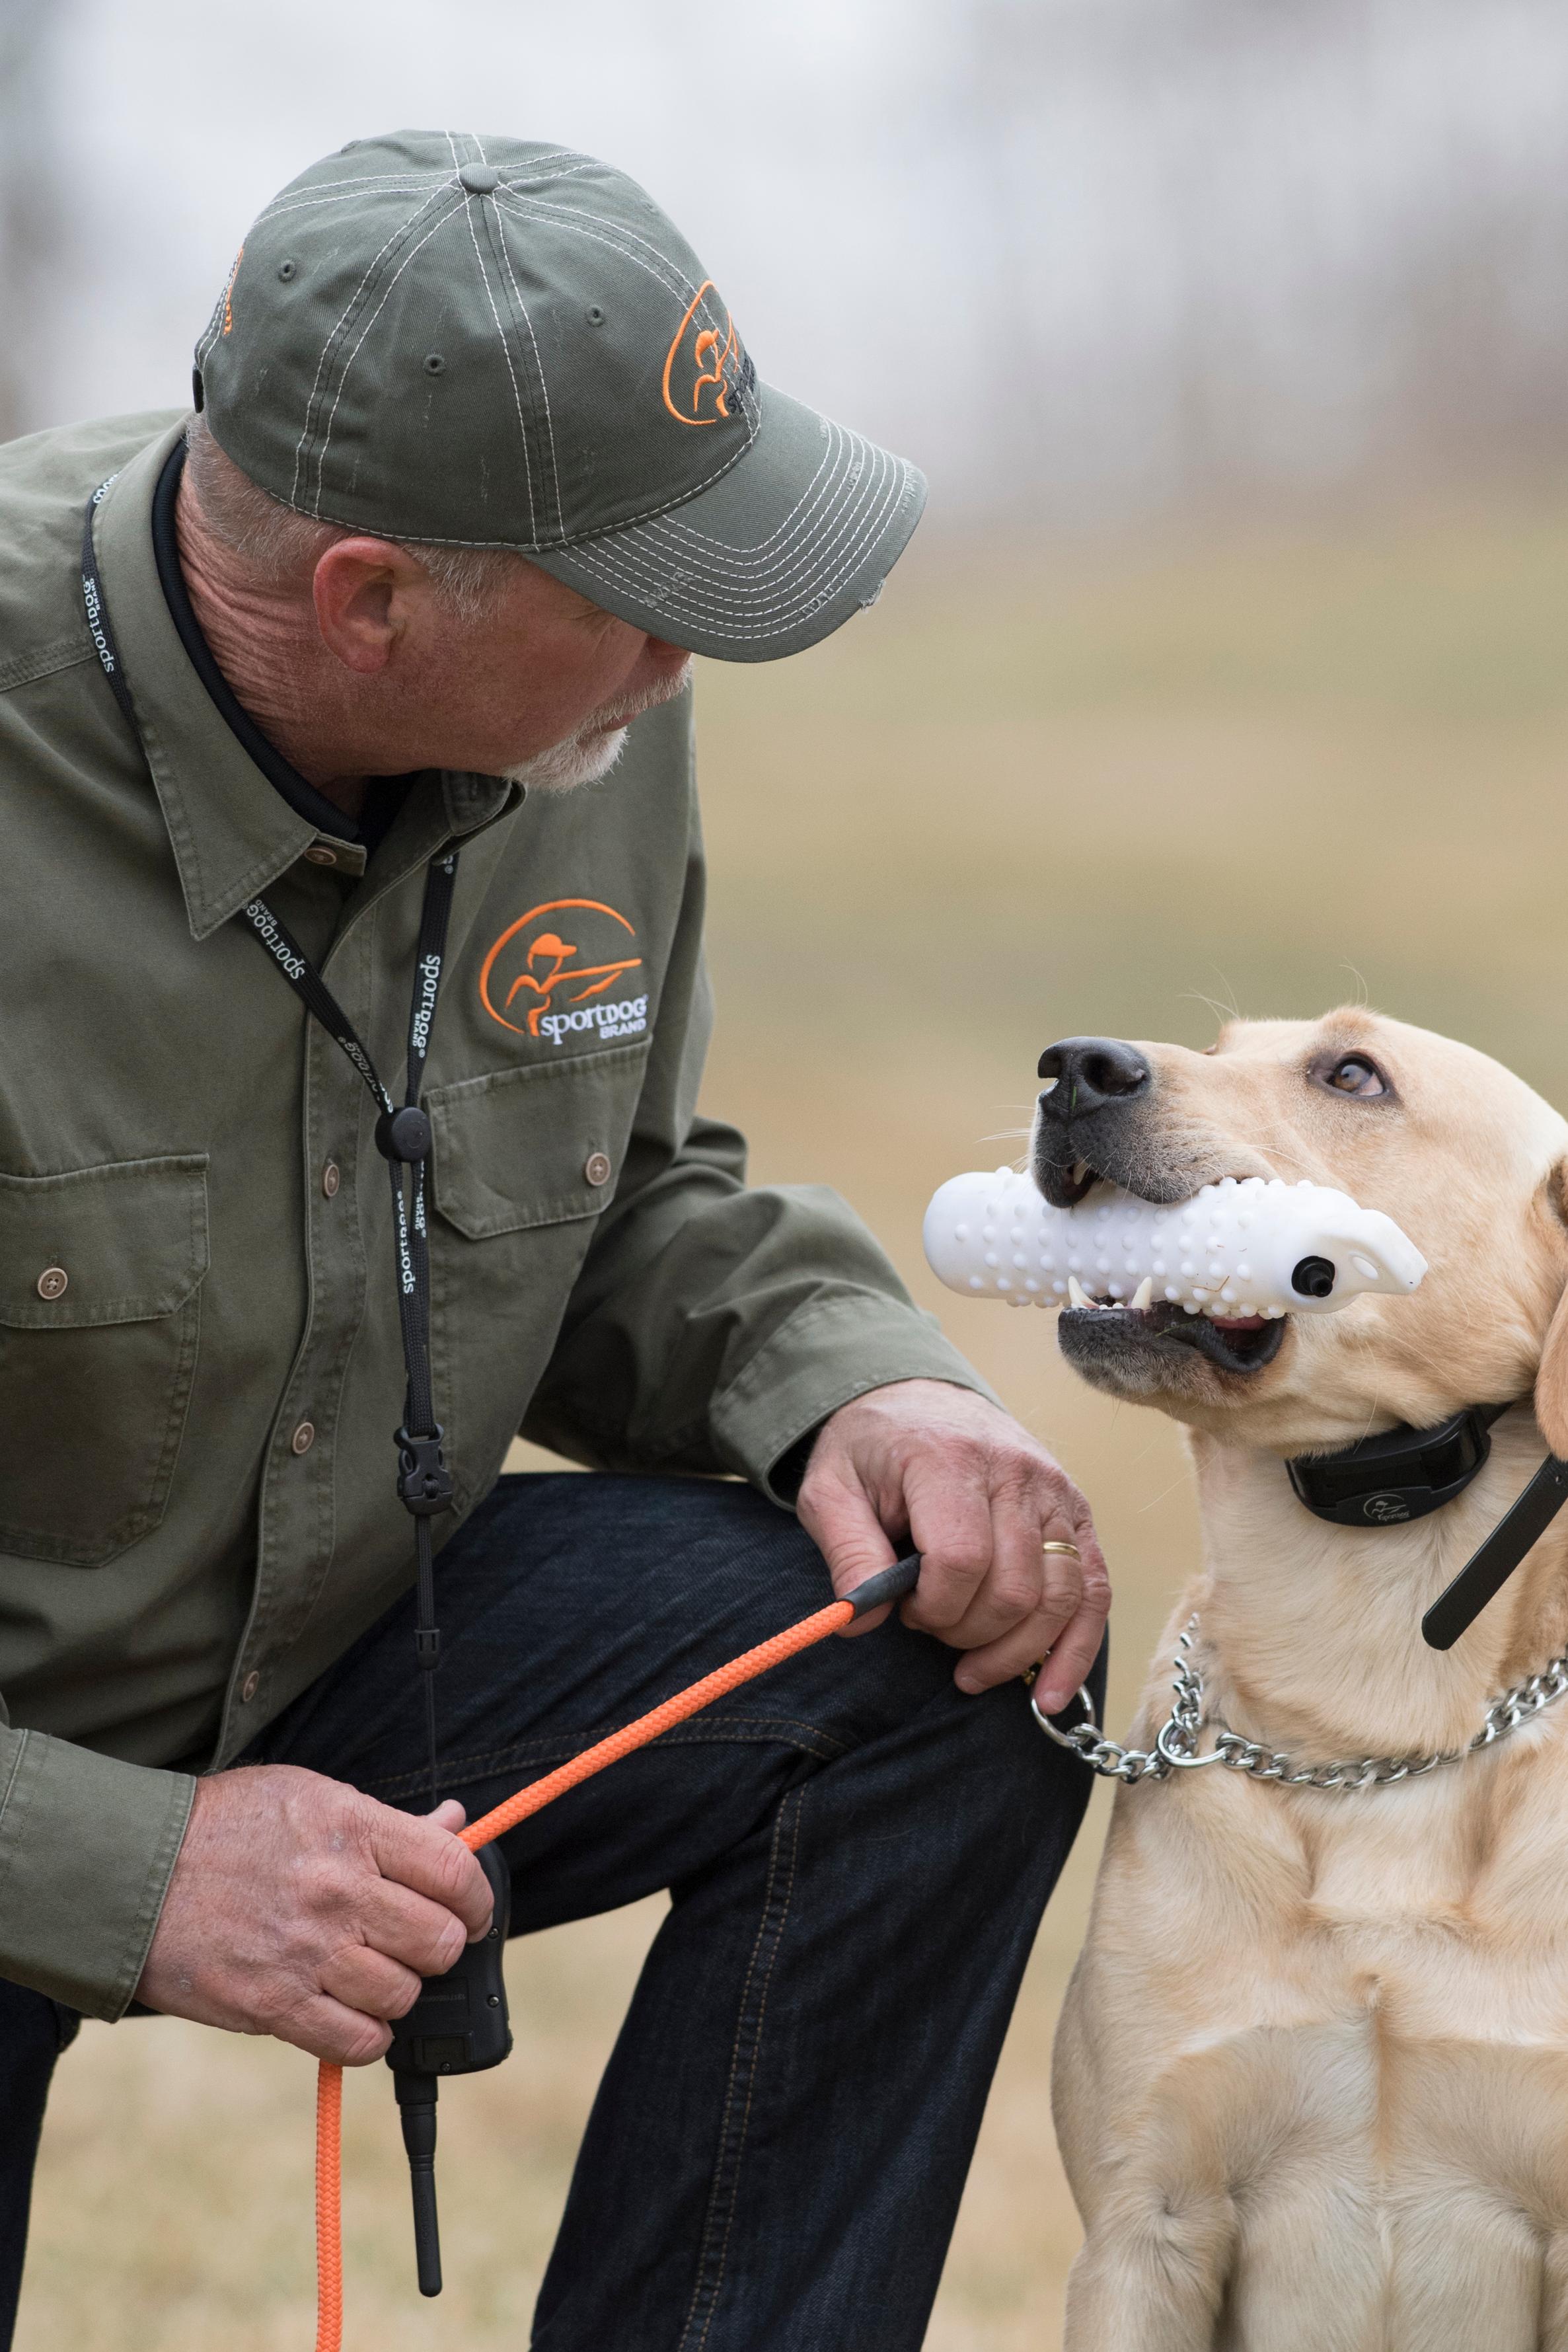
[83,473,459,1804]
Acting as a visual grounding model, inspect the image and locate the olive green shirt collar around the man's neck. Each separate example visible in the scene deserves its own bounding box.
[94,421,522,938]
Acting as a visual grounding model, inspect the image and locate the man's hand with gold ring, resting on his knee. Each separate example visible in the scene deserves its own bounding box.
[797,1381,1109,1715]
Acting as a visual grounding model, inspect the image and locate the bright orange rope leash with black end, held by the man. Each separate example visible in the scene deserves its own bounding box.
[315,1554,919,2352]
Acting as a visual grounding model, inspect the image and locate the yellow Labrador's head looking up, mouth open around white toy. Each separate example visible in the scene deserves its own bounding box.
[1032,1009,1568,1453]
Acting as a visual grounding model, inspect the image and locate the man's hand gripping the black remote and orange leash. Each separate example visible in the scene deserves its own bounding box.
[136,1764,492,2065]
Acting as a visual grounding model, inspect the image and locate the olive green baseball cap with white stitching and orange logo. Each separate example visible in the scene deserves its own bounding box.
[195,132,926,661]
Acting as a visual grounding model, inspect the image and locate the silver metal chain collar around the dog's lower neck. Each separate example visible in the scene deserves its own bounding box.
[1029,1613,1568,1792]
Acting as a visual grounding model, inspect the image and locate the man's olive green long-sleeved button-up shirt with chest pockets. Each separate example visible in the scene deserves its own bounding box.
[0,416,981,2018]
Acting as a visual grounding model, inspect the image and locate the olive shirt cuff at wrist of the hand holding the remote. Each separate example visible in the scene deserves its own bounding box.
[0,1731,195,2018]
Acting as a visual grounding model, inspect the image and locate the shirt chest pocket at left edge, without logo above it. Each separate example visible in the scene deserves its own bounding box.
[0,1153,207,1569]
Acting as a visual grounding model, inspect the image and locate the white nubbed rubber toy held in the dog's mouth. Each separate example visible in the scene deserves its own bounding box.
[926,1169,1427,1322]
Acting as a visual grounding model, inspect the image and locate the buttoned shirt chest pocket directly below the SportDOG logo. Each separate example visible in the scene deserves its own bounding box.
[426,1038,649,1503]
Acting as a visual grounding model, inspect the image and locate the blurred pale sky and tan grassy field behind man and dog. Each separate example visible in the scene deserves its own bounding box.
[0,0,1568,2352]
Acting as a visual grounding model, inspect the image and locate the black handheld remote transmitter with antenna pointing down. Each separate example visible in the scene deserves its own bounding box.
[385,1846,513,2296]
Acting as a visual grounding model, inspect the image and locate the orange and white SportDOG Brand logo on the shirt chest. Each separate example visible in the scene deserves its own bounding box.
[480,899,649,1047]
